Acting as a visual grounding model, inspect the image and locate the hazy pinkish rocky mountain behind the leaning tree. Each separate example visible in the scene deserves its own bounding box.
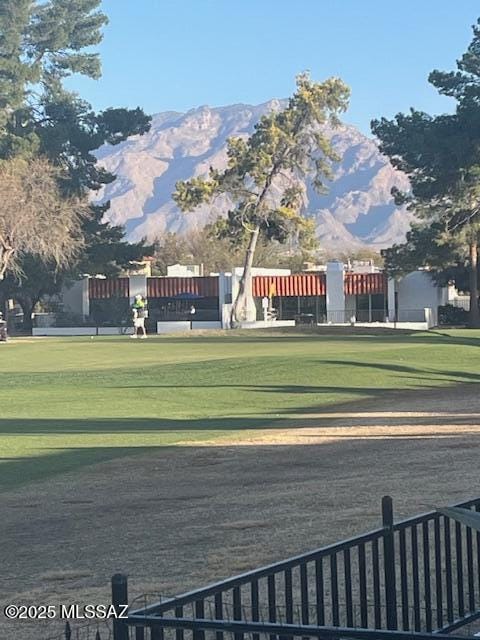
[94,100,411,250]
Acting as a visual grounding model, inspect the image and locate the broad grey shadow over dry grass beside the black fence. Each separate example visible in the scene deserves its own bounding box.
[0,430,478,596]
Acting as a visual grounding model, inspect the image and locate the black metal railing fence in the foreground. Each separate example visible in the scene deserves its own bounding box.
[42,496,480,640]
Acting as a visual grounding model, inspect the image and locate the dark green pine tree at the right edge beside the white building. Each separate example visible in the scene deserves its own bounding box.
[372,17,480,326]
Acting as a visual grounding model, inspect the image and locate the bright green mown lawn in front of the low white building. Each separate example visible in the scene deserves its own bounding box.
[0,330,480,489]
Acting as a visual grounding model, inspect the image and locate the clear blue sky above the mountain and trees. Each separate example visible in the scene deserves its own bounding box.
[69,0,480,133]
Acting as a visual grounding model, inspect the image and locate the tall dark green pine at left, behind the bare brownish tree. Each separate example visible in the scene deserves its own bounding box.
[0,0,153,320]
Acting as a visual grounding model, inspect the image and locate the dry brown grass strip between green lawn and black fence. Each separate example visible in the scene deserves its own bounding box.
[0,385,480,640]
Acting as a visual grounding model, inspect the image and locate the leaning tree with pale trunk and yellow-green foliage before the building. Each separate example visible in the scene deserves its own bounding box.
[173,74,349,322]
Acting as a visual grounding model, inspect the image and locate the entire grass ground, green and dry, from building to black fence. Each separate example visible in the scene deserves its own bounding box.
[0,328,480,640]
